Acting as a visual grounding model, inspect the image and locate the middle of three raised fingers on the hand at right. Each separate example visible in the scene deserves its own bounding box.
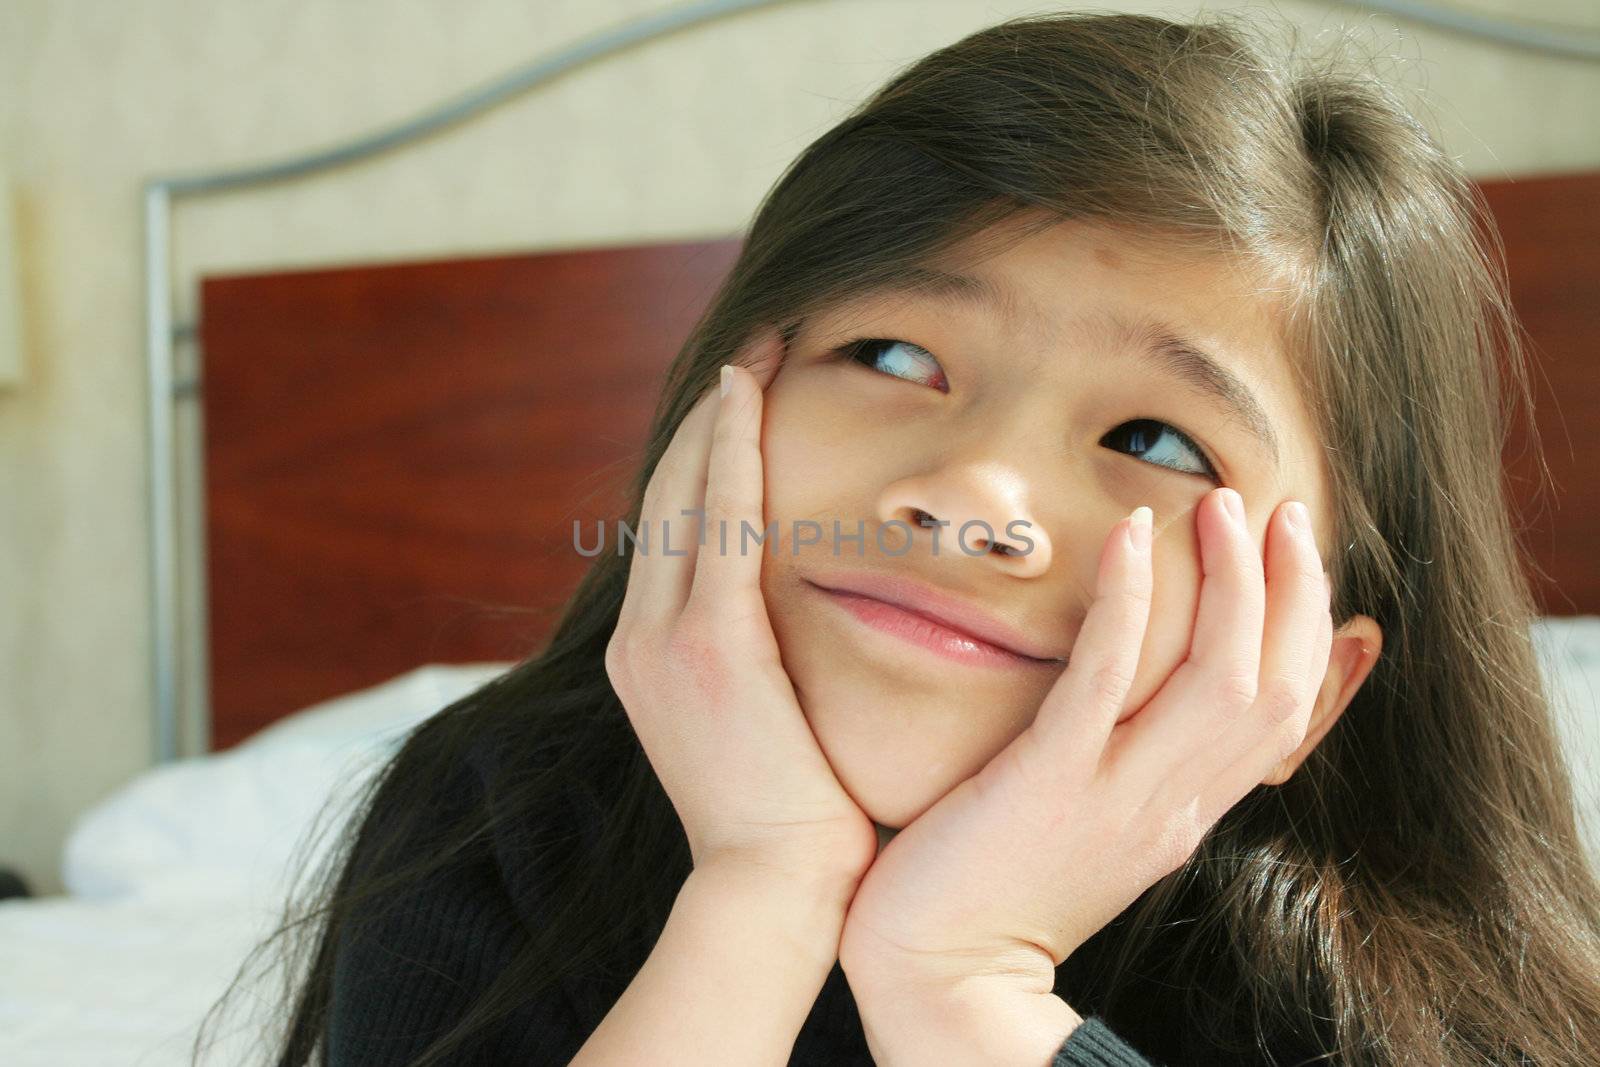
[1118,488,1266,782]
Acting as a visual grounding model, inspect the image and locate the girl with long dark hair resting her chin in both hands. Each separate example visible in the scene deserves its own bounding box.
[206,14,1600,1067]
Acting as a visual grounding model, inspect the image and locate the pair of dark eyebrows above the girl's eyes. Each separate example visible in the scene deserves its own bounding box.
[870,266,1282,469]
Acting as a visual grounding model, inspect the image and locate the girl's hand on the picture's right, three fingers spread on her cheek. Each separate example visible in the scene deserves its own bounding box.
[838,488,1333,993]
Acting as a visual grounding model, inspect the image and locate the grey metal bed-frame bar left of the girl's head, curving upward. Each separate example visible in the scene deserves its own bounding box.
[144,0,806,763]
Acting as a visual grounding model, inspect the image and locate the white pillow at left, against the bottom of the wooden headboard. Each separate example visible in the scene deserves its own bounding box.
[61,664,514,899]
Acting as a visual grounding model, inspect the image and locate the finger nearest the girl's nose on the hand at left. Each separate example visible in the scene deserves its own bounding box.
[690,331,781,621]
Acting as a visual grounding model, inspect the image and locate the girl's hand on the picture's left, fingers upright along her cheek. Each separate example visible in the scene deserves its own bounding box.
[605,330,877,889]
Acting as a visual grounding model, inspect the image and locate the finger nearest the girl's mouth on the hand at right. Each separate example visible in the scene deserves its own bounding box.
[1030,506,1154,766]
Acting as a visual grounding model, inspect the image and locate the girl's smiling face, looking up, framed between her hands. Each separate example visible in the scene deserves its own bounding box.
[752,221,1328,829]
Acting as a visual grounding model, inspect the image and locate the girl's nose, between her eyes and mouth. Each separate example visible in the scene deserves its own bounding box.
[878,462,1050,577]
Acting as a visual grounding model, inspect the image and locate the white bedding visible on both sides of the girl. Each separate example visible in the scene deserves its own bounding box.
[0,627,1600,1067]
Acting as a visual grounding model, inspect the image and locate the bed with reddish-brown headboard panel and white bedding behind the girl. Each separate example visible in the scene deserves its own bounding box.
[0,79,1600,1067]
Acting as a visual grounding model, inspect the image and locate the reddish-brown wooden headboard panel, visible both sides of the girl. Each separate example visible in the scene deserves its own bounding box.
[200,173,1600,749]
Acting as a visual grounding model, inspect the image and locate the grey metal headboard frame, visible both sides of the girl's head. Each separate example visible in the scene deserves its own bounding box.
[144,0,1600,763]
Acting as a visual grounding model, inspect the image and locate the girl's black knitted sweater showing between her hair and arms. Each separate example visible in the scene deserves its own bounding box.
[326,723,1149,1067]
